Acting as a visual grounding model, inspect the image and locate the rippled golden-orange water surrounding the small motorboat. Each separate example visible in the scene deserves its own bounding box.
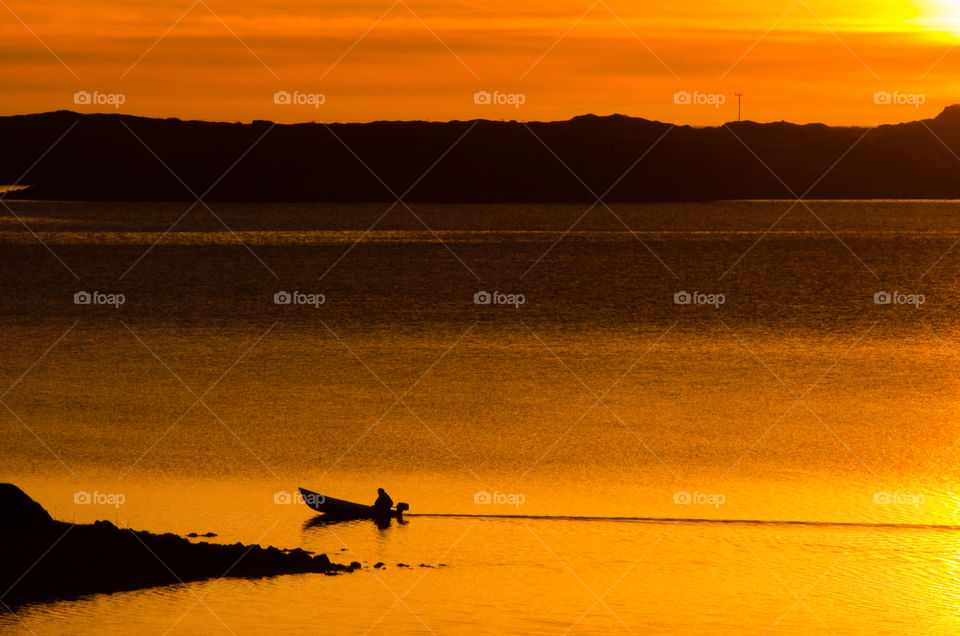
[0,201,960,634]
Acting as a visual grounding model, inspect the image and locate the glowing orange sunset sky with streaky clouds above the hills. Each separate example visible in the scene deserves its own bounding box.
[0,0,960,125]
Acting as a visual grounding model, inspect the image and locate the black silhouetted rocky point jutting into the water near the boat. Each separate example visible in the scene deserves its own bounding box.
[0,484,361,612]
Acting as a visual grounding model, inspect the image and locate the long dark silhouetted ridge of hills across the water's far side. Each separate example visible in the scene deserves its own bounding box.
[0,105,960,203]
